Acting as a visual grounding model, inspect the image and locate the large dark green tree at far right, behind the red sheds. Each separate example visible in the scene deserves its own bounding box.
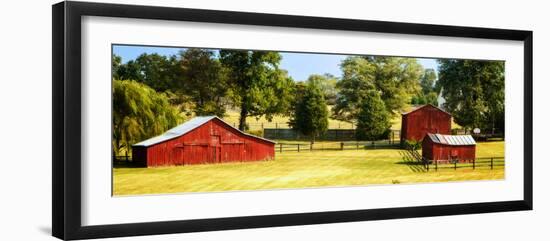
[438,59,504,131]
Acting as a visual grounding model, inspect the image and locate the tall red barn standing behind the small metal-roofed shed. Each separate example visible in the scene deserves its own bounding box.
[401,104,452,143]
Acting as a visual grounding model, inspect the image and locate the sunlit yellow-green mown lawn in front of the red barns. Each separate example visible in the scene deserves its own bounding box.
[113,142,504,195]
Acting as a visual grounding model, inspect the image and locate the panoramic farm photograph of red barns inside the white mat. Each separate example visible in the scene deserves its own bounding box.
[111,44,505,196]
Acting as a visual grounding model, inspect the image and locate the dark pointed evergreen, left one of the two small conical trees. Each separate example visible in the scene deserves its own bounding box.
[289,82,329,143]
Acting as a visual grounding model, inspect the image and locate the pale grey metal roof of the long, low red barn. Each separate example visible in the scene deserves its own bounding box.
[132,116,275,147]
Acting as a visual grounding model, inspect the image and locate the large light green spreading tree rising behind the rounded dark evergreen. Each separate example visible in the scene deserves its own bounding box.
[333,56,423,121]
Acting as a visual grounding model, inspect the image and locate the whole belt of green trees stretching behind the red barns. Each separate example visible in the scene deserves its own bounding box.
[112,48,504,155]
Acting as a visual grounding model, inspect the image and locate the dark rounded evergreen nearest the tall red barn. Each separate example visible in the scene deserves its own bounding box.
[356,90,391,141]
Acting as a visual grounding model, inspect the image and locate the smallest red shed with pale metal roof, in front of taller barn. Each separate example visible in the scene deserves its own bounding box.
[422,133,476,162]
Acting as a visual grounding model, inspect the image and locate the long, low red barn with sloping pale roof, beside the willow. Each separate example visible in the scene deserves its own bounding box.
[132,116,275,167]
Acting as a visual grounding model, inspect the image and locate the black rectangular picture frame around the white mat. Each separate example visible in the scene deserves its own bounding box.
[52,2,533,240]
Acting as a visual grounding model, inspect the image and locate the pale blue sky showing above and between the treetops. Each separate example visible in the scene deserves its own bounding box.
[113,45,437,80]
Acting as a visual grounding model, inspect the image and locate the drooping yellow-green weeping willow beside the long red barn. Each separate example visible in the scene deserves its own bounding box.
[112,80,181,156]
